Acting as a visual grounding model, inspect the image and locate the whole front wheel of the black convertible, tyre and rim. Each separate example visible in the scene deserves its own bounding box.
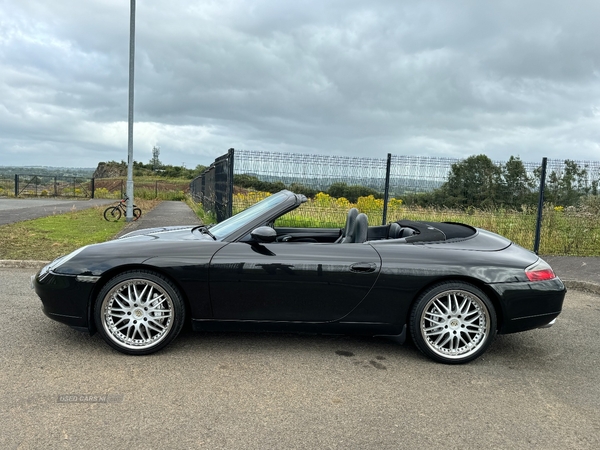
[94,270,185,355]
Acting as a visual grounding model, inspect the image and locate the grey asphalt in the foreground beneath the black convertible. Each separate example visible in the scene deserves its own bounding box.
[0,269,600,450]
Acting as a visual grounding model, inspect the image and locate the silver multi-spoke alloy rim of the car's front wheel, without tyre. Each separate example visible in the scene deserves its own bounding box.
[101,278,174,350]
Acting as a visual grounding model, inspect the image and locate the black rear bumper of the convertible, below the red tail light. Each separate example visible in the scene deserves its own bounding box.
[489,278,567,334]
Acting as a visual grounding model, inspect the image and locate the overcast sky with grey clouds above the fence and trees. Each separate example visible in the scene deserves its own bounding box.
[0,0,600,167]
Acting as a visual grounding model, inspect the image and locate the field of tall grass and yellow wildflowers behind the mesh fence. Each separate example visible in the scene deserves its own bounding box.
[233,191,600,256]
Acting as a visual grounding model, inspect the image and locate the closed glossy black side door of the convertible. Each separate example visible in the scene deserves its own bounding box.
[209,242,381,322]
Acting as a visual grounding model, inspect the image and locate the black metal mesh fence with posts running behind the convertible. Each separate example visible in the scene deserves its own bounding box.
[190,149,600,256]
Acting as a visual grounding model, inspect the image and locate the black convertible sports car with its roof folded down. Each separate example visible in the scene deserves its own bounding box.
[32,190,566,364]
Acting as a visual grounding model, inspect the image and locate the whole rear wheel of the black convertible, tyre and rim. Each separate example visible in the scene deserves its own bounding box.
[410,281,496,364]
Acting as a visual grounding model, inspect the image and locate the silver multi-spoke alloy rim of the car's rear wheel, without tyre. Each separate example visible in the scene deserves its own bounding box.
[419,290,491,359]
